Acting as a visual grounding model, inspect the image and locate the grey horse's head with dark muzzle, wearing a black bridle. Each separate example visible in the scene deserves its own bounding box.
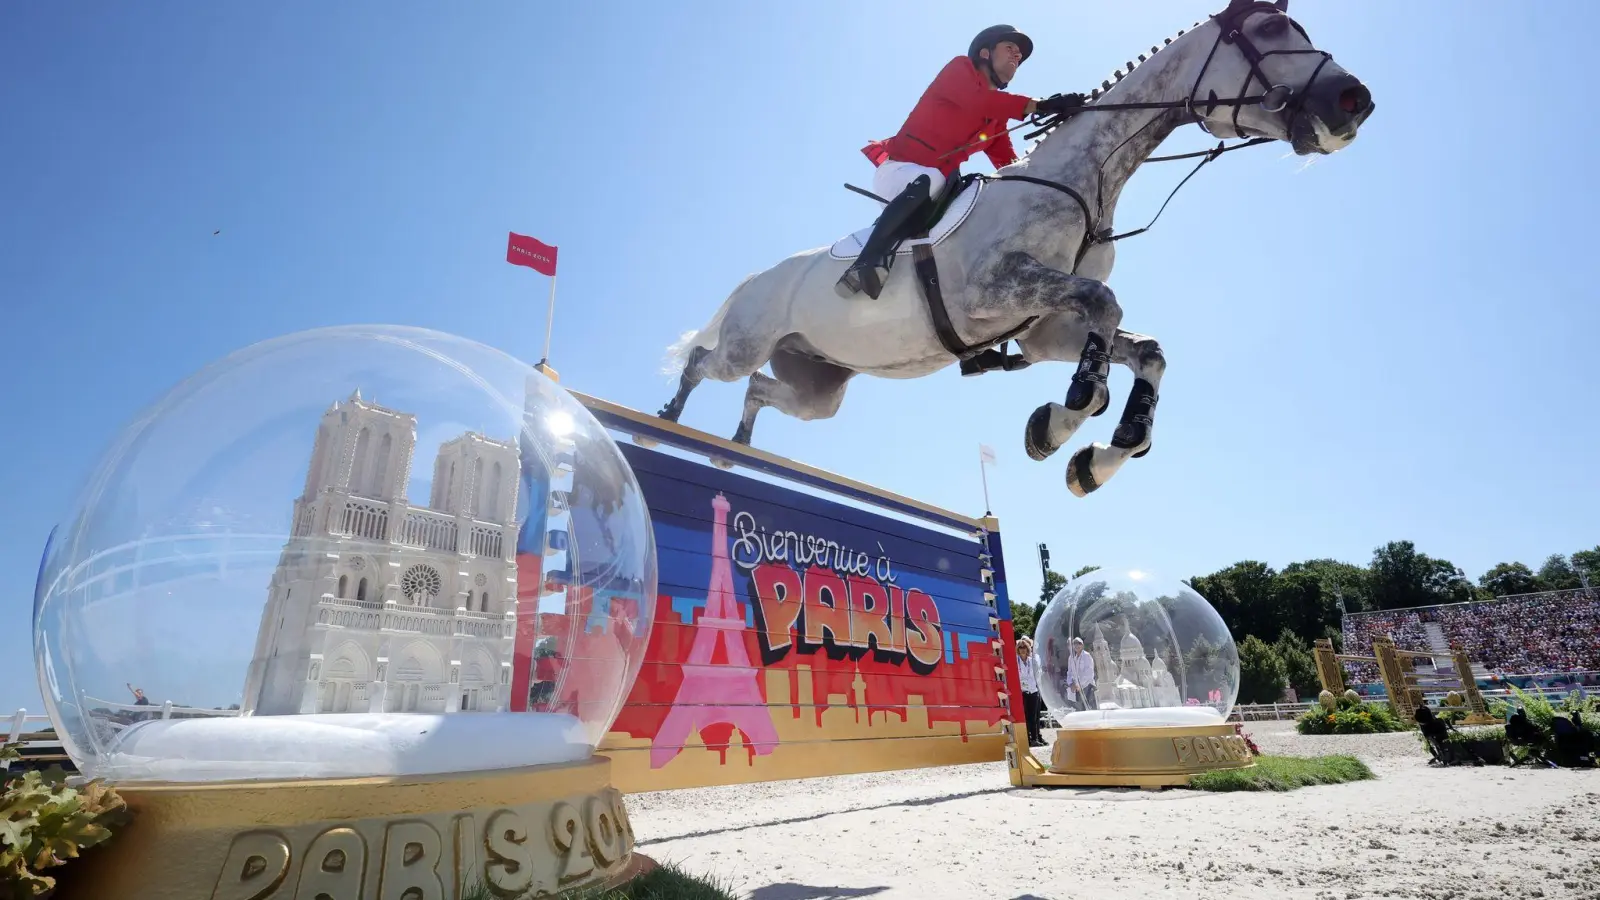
[1190,0,1373,155]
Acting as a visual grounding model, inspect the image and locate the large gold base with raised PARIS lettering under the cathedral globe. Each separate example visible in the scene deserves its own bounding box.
[59,756,636,900]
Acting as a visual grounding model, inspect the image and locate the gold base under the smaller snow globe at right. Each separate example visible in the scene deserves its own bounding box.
[1006,722,1256,790]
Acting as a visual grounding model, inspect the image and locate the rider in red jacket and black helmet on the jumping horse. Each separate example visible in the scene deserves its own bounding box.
[838,26,1083,299]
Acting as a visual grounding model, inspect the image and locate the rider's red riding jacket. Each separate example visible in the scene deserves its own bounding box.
[861,56,1030,178]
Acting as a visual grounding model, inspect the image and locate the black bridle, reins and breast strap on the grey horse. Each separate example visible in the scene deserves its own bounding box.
[974,0,1333,271]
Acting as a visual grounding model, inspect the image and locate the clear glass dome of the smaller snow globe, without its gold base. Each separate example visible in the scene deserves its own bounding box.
[1034,567,1238,729]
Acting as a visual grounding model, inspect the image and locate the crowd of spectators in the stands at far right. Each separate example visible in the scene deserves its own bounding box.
[1342,589,1600,682]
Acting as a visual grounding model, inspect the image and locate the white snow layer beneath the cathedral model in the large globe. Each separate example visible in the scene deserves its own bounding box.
[83,713,590,781]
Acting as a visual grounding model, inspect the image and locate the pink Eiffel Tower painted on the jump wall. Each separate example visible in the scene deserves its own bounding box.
[650,493,778,769]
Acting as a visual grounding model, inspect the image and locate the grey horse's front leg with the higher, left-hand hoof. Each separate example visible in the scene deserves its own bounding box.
[972,253,1122,460]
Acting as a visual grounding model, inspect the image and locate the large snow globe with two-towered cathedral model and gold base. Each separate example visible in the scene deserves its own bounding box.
[34,325,656,898]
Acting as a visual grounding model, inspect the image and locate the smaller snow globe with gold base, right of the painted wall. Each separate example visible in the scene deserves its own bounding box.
[1034,565,1251,786]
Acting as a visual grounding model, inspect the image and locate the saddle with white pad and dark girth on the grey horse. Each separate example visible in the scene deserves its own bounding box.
[829,173,1035,376]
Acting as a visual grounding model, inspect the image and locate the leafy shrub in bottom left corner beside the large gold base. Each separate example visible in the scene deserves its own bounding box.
[0,745,128,898]
